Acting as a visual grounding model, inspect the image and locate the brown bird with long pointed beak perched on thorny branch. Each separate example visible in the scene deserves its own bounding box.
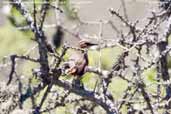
[63,39,98,88]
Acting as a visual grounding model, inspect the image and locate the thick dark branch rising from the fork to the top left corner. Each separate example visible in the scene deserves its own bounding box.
[11,0,49,82]
